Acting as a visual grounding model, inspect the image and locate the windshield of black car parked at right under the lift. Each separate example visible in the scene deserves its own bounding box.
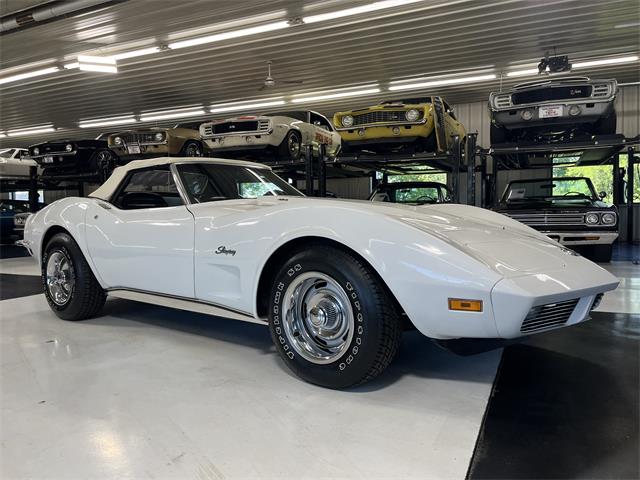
[502,178,597,203]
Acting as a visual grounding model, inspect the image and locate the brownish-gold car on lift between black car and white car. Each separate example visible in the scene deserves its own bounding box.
[107,122,204,163]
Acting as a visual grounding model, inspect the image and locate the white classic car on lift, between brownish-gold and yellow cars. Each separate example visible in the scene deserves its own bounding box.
[200,110,340,160]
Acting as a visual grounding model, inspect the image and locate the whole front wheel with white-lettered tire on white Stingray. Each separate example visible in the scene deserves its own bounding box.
[269,245,402,388]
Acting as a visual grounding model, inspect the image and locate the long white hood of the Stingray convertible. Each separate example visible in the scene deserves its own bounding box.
[286,199,585,277]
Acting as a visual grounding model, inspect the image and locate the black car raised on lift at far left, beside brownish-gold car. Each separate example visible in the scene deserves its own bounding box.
[29,133,119,183]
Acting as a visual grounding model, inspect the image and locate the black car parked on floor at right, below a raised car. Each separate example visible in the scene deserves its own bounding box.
[494,177,618,262]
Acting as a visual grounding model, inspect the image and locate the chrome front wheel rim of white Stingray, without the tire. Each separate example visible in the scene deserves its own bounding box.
[282,272,354,364]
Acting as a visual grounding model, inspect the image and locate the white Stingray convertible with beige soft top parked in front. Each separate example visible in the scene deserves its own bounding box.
[22,158,618,388]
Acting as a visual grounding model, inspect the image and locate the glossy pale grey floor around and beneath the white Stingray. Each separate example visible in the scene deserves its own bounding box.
[0,258,640,479]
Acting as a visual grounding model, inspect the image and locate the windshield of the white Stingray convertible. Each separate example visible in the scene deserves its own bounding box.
[178,163,303,203]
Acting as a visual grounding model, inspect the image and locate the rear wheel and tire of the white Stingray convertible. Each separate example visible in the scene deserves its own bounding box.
[42,233,107,321]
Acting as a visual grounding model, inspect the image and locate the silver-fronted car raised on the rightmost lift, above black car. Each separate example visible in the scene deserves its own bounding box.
[489,77,618,145]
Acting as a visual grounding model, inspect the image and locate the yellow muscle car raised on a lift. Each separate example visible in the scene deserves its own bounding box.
[333,97,467,154]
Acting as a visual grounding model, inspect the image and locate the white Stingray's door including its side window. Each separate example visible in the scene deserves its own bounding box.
[85,165,194,298]
